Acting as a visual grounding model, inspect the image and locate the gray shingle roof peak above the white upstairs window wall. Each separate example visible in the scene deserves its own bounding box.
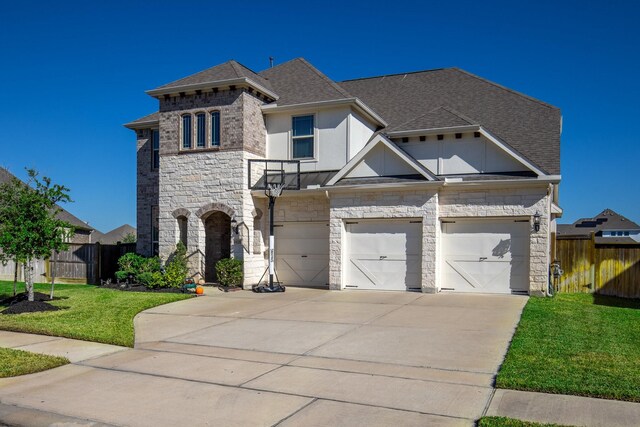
[260,58,353,106]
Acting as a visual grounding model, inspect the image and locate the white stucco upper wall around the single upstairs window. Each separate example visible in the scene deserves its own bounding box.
[267,107,351,171]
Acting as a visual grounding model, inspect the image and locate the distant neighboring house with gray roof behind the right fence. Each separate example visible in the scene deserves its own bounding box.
[558,209,640,245]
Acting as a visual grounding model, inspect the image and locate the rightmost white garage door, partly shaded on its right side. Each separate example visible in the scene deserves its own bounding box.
[441,220,530,293]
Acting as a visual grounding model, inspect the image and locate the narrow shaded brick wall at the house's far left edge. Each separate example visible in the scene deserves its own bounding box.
[136,129,162,256]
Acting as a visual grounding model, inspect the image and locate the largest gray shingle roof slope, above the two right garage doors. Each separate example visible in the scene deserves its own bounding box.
[339,68,560,174]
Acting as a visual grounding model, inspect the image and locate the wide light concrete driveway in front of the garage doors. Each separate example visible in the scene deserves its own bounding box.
[0,288,526,426]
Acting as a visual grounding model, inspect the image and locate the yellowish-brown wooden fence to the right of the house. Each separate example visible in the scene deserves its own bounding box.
[556,236,640,298]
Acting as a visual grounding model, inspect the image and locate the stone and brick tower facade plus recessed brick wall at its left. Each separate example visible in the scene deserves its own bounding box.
[145,90,266,284]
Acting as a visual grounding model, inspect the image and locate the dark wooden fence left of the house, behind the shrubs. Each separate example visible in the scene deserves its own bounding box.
[46,243,136,284]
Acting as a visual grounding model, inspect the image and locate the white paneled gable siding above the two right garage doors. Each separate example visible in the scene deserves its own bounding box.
[398,133,528,175]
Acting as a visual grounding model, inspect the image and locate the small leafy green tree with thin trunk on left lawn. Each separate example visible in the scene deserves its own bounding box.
[0,169,73,301]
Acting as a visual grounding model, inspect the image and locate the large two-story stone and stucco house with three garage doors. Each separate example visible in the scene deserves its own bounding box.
[126,59,562,295]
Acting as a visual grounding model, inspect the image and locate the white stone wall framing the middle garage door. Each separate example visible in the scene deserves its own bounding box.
[329,190,440,293]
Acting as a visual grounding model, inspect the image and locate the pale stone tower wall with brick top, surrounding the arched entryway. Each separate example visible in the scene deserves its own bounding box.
[158,90,266,285]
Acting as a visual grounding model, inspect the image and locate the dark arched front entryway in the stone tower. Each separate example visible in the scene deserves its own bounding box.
[202,211,231,282]
